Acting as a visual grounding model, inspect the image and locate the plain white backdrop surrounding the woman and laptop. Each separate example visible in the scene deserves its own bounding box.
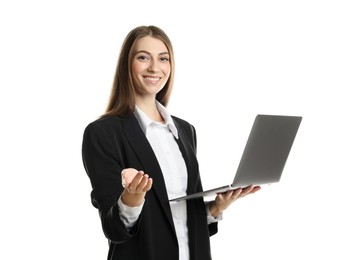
[0,0,364,260]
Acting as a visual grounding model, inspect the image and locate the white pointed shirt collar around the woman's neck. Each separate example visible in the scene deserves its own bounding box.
[134,101,178,139]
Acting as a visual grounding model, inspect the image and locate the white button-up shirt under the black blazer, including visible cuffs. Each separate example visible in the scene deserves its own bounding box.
[118,102,222,260]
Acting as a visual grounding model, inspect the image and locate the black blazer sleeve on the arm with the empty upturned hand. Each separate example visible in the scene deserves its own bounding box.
[82,121,138,243]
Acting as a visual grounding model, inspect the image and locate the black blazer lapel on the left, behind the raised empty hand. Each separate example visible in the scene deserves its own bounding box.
[121,115,174,232]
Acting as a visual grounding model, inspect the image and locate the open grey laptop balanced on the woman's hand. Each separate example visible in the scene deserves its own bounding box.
[170,114,302,202]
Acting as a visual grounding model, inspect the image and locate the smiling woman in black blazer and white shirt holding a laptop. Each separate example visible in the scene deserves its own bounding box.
[82,26,260,260]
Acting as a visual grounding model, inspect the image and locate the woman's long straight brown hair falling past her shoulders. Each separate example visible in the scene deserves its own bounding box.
[103,26,174,116]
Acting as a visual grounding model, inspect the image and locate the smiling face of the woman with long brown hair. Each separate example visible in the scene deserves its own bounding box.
[131,36,171,98]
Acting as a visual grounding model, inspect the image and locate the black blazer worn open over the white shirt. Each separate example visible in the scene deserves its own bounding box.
[82,115,217,260]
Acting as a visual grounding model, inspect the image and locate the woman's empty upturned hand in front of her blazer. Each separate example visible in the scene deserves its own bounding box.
[121,168,153,207]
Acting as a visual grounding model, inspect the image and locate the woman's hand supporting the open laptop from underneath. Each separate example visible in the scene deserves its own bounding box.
[209,185,261,217]
